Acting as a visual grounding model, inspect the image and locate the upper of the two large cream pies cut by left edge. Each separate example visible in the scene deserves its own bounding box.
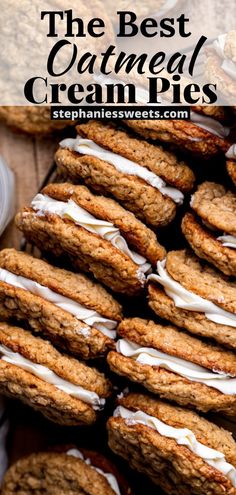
[0,249,122,359]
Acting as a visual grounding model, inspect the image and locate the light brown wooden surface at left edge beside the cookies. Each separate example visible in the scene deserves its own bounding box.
[0,125,59,249]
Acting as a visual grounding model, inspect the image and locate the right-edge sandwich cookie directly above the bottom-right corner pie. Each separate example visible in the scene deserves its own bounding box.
[107,318,236,416]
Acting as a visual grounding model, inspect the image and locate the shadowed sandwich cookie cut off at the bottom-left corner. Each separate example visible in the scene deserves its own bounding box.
[2,447,132,495]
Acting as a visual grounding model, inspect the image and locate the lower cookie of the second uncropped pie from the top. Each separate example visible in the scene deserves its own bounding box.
[16,208,145,295]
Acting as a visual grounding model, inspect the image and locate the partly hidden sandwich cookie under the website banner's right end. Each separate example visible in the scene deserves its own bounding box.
[126,107,230,158]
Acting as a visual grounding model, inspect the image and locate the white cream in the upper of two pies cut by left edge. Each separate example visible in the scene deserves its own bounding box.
[0,268,117,339]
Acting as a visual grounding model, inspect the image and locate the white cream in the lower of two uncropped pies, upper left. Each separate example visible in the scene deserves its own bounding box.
[31,194,151,280]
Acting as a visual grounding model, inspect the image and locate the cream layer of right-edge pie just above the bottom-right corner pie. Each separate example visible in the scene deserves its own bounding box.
[116,339,236,395]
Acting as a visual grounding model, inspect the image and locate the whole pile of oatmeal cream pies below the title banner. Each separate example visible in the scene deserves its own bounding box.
[0,112,236,495]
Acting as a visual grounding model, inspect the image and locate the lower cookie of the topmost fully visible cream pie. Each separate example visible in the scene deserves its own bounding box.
[55,148,176,227]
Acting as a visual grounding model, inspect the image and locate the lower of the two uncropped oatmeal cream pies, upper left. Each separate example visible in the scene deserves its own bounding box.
[16,183,165,295]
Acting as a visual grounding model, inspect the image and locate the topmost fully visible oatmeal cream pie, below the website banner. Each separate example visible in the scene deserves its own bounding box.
[56,121,194,227]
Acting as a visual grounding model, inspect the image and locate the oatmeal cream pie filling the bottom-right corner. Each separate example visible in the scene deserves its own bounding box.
[107,394,236,495]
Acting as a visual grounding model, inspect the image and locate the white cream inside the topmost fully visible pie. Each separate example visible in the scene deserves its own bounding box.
[60,135,184,204]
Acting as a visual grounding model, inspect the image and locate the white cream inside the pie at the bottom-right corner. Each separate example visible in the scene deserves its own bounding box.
[114,406,236,487]
